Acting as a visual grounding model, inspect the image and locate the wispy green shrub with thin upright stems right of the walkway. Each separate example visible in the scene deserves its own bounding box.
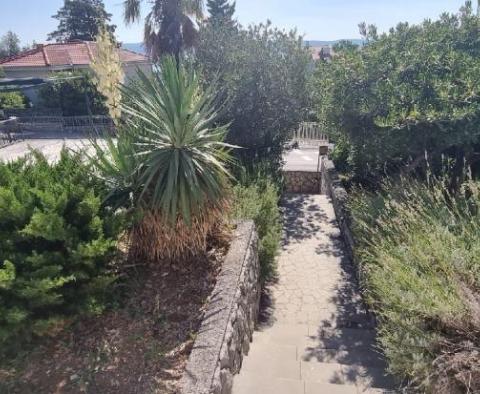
[350,181,480,393]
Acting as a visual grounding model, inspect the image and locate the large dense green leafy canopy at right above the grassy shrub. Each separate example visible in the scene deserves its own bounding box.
[314,2,480,185]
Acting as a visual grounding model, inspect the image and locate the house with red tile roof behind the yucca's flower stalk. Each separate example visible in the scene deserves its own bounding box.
[0,41,152,79]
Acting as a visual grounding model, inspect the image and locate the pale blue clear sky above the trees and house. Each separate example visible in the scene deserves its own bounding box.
[0,0,465,44]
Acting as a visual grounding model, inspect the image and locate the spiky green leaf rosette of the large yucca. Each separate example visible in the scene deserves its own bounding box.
[119,57,231,224]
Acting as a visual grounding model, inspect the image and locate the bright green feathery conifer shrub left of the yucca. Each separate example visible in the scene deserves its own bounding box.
[0,151,123,349]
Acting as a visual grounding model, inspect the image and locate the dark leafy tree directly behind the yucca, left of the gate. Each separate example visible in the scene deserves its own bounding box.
[196,23,312,168]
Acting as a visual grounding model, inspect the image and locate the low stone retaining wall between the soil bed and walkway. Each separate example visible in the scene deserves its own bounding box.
[180,221,261,394]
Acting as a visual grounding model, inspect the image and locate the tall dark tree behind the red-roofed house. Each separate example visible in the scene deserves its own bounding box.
[48,0,116,42]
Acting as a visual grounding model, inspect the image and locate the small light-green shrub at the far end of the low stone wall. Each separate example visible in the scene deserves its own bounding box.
[232,178,282,281]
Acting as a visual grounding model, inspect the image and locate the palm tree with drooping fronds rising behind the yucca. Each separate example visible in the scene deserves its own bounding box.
[124,0,203,64]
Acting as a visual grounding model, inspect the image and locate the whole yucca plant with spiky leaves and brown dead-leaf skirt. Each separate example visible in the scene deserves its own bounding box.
[91,57,232,260]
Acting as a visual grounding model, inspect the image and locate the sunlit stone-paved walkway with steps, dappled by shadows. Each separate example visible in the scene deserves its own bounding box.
[233,195,392,394]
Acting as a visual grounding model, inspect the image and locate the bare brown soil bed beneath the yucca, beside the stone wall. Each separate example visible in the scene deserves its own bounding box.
[0,247,226,394]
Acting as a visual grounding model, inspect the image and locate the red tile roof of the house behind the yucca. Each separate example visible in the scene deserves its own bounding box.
[0,41,148,68]
